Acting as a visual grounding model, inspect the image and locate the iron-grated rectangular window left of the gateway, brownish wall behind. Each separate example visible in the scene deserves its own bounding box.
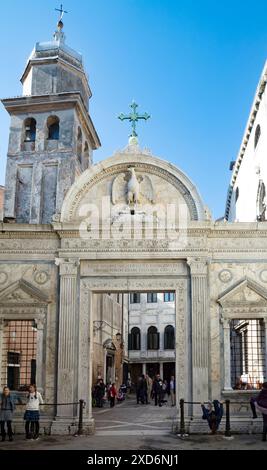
[1,320,37,391]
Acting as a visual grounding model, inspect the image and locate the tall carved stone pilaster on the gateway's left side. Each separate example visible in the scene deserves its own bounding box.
[57,260,79,421]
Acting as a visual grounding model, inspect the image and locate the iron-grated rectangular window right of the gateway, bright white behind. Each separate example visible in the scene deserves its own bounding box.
[230,319,266,390]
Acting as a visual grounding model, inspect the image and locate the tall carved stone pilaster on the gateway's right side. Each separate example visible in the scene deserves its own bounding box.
[187,258,209,410]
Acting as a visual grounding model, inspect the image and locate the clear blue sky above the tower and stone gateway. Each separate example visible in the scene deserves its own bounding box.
[0,0,267,218]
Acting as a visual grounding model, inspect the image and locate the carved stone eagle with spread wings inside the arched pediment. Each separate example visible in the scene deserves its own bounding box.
[111,167,155,206]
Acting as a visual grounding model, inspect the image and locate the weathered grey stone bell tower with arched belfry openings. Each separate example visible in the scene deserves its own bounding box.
[2,19,101,224]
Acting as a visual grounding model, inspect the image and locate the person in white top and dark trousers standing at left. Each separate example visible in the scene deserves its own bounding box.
[24,384,44,440]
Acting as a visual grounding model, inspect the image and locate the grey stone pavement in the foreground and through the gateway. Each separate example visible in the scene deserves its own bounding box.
[0,399,267,451]
